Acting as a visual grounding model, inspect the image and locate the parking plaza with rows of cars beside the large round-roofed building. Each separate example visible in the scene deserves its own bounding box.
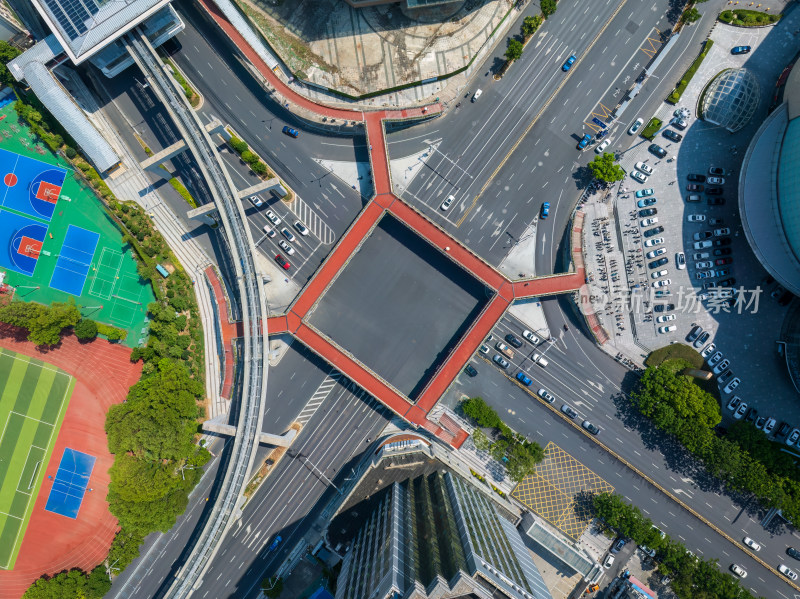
[585,9,800,426]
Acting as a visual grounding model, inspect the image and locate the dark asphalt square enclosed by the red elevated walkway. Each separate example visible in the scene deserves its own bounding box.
[310,215,488,399]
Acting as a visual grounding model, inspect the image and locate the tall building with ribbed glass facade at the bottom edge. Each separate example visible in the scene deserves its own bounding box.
[336,471,550,599]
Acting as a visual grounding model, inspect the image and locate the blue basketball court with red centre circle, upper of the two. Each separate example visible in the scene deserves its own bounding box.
[0,149,67,221]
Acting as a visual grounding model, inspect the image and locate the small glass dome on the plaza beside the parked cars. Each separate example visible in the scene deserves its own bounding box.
[700,69,761,133]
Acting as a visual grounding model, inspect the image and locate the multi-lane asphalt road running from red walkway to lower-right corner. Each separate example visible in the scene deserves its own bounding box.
[448,299,798,598]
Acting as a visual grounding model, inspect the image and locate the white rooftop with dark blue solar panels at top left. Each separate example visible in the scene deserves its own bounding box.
[31,0,169,64]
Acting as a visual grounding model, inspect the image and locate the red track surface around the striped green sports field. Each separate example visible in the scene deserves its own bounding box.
[0,325,142,599]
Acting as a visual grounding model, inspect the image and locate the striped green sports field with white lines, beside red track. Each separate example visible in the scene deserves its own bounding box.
[0,348,75,570]
